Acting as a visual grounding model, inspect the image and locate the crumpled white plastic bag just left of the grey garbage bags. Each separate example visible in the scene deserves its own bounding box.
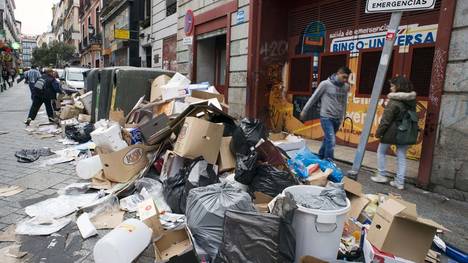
[135,177,171,213]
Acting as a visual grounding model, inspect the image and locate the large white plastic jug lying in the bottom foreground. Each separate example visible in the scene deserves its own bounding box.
[93,218,152,263]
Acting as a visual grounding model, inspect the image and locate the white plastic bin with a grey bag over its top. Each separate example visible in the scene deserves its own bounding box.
[283,185,351,262]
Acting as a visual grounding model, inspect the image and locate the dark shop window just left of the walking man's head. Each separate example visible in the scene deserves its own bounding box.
[288,56,313,95]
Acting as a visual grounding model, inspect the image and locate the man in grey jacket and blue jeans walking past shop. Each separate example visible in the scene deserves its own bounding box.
[300,67,351,160]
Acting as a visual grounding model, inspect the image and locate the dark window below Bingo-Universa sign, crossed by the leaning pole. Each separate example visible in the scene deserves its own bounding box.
[357,49,395,96]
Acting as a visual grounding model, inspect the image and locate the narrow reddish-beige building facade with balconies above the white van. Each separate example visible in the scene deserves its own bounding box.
[79,0,103,68]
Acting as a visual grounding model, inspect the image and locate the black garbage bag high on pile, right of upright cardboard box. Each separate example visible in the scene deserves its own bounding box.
[230,118,268,155]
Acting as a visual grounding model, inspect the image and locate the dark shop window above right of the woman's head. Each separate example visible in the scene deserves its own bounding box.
[410,46,434,97]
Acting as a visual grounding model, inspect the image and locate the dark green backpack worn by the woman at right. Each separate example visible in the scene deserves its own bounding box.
[396,105,419,145]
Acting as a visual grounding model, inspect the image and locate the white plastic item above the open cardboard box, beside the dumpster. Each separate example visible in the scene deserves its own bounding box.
[91,125,128,152]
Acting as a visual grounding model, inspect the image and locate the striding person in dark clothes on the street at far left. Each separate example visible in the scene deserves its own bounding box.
[24,69,57,126]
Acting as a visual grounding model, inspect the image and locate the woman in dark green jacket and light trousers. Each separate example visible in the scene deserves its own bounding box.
[371,76,417,190]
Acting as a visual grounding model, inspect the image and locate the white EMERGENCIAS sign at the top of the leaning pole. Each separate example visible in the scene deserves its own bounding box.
[366,0,436,13]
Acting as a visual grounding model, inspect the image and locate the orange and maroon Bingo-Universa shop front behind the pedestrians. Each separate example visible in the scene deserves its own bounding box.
[247,0,458,186]
